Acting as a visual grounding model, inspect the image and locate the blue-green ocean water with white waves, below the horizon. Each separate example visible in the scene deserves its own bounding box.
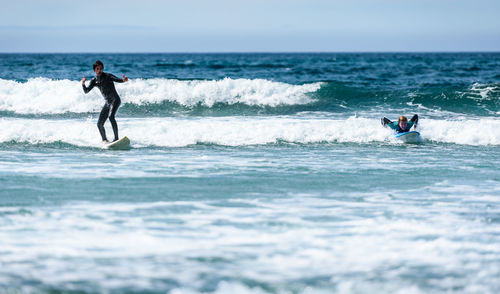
[0,53,500,294]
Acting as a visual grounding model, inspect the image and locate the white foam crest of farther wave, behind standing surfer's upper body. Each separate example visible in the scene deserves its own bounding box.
[0,78,321,114]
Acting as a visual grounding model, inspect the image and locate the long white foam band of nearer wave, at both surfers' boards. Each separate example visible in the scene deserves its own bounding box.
[0,116,500,147]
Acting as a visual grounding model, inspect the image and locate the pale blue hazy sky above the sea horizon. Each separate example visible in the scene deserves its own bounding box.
[0,0,500,52]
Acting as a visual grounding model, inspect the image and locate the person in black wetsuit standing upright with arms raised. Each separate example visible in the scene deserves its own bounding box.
[82,60,128,143]
